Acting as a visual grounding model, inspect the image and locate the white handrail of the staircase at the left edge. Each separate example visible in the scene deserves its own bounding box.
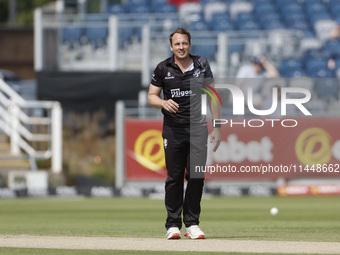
[0,78,62,173]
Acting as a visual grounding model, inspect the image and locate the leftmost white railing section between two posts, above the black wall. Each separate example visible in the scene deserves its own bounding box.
[34,8,119,71]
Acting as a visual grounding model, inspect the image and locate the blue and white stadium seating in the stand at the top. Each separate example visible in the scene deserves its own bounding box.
[67,0,340,81]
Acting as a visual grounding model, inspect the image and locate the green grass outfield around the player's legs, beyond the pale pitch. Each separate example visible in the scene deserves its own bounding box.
[0,196,340,255]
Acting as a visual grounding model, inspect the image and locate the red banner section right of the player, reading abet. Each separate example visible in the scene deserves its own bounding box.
[206,118,340,180]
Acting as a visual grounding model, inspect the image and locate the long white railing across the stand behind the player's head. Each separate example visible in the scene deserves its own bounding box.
[34,9,303,87]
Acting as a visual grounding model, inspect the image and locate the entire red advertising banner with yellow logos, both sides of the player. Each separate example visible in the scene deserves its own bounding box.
[125,118,340,181]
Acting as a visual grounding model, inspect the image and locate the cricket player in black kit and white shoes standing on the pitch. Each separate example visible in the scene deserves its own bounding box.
[148,28,221,239]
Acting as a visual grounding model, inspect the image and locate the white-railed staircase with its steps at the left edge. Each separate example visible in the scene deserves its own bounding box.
[0,77,62,187]
